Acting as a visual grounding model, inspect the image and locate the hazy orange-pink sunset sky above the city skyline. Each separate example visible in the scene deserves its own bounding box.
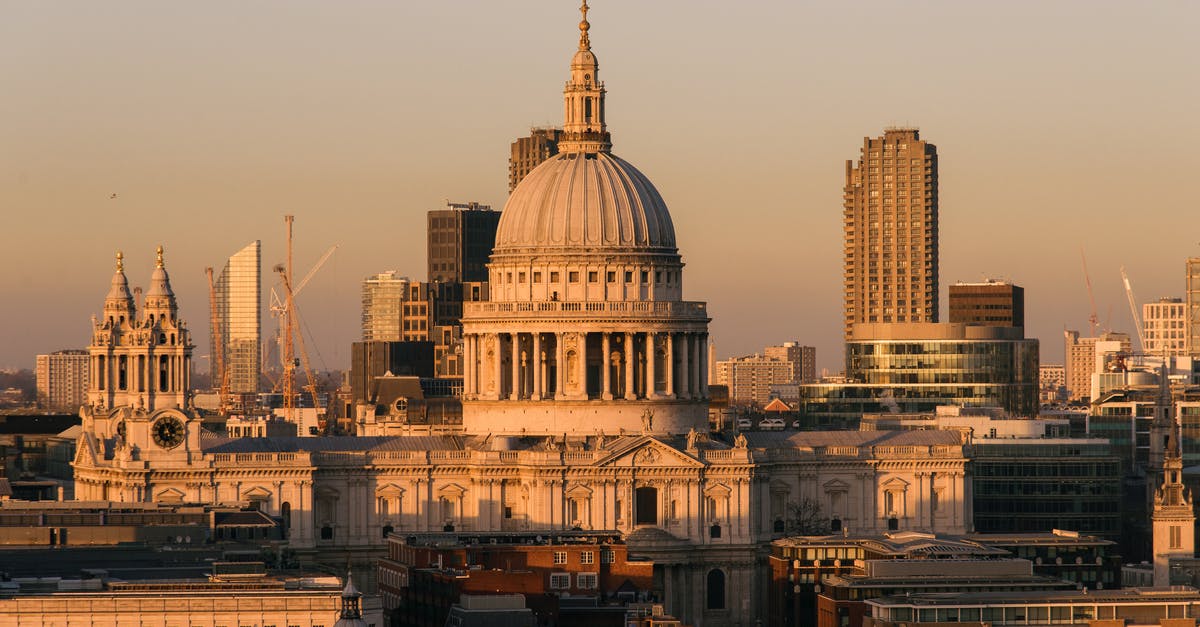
[0,0,1200,372]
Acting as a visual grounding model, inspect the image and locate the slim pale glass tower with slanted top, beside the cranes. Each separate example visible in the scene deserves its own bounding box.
[211,240,263,394]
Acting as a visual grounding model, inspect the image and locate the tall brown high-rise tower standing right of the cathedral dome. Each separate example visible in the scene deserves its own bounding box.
[844,129,938,340]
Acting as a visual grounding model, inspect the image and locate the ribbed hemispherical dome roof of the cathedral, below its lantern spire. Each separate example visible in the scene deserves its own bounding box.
[493,151,676,255]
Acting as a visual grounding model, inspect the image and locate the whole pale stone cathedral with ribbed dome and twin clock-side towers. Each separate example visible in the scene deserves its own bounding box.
[74,5,971,626]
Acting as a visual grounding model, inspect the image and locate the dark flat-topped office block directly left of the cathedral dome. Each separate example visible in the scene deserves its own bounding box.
[428,202,500,283]
